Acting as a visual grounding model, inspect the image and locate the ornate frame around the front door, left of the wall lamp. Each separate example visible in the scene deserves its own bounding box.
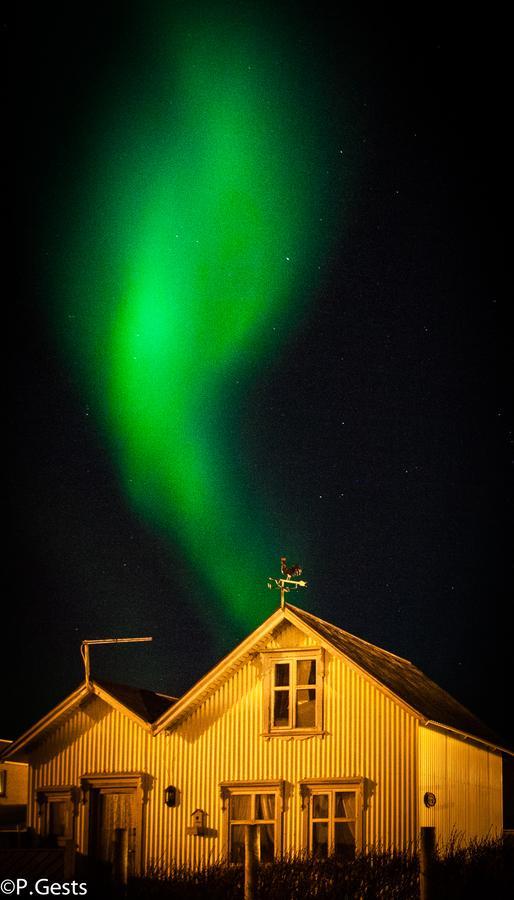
[80,772,147,875]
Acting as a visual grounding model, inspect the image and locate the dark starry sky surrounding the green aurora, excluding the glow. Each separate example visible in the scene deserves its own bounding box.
[6,2,514,742]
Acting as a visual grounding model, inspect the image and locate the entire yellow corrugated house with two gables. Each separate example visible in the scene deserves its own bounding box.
[1,603,512,872]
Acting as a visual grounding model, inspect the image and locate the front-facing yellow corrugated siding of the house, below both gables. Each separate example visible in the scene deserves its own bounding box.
[31,625,418,866]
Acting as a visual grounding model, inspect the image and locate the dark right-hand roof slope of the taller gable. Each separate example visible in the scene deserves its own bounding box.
[287,603,504,747]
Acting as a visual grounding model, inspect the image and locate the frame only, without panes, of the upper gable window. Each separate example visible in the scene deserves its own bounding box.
[261,647,325,737]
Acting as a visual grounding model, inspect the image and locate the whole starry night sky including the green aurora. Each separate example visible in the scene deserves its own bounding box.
[6,2,514,742]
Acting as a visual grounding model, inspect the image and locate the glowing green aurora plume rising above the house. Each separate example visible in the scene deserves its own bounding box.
[51,4,342,628]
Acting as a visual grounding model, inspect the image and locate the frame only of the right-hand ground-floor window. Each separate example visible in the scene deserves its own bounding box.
[300,778,364,856]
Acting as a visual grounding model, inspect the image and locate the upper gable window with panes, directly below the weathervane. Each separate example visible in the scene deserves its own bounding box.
[264,650,322,734]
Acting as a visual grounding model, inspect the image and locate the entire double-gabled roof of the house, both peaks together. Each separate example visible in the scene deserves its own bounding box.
[0,603,508,760]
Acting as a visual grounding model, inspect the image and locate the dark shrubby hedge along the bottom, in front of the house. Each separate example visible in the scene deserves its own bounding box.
[128,838,514,900]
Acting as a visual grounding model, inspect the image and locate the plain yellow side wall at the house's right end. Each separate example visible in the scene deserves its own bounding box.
[419,726,503,845]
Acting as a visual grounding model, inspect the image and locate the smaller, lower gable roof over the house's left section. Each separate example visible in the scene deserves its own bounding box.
[0,679,177,760]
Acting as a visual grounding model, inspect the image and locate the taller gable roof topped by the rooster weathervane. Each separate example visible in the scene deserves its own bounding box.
[154,603,506,753]
